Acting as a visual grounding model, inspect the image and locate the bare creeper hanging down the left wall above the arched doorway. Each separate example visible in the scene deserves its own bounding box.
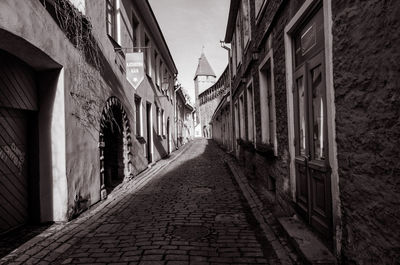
[42,0,113,139]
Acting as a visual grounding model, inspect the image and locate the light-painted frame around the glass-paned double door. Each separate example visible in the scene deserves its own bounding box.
[284,0,342,256]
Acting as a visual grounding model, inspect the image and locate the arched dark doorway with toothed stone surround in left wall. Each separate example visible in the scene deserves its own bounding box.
[99,96,133,199]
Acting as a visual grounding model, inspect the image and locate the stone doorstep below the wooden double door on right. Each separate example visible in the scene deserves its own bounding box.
[278,217,337,265]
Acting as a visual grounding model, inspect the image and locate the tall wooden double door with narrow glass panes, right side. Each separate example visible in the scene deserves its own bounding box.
[293,8,332,239]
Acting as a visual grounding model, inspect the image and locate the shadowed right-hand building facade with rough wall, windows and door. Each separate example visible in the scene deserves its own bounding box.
[213,0,400,264]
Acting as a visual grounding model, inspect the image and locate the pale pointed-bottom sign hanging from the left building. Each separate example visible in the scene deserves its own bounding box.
[126,52,144,89]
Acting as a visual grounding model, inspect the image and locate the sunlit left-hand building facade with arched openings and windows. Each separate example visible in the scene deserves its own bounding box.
[0,0,177,233]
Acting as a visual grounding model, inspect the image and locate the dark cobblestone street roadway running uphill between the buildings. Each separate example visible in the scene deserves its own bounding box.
[2,140,279,265]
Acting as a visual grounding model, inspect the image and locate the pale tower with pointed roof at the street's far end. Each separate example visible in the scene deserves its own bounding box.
[194,51,216,137]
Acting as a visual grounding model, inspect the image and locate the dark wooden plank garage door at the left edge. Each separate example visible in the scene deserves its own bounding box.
[0,51,37,233]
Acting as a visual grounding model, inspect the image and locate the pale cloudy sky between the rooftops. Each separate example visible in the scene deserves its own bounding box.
[149,0,230,102]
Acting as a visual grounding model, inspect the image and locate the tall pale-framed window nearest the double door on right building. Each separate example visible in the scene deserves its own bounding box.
[259,50,277,153]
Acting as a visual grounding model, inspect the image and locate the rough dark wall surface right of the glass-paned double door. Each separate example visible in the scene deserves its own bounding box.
[332,0,400,264]
